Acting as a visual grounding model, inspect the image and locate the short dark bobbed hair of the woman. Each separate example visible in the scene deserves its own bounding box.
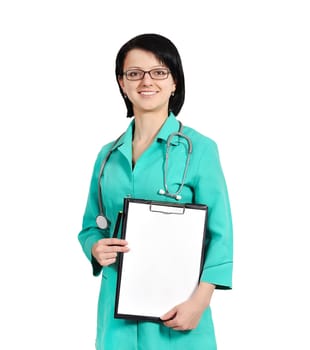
[115,34,185,118]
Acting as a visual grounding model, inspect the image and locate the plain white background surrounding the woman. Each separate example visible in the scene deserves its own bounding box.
[0,0,310,350]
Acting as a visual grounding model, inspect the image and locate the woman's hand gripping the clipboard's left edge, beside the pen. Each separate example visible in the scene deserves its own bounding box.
[92,238,129,266]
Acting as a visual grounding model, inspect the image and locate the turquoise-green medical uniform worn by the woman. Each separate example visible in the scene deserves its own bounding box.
[78,113,233,350]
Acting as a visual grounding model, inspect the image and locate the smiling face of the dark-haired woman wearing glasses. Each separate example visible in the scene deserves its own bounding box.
[119,49,176,116]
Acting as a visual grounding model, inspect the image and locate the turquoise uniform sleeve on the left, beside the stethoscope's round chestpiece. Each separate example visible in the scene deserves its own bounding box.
[78,150,109,276]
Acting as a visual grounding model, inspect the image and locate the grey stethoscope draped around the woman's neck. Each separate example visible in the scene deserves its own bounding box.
[96,122,193,229]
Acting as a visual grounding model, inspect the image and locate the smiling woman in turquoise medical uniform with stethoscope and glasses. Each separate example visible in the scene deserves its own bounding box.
[78,34,233,350]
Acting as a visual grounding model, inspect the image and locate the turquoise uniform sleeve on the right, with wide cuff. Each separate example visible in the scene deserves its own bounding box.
[195,140,233,289]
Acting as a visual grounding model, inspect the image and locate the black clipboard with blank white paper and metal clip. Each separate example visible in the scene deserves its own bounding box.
[114,198,208,322]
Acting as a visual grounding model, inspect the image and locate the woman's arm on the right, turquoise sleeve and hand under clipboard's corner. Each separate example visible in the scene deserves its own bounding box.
[161,141,232,330]
